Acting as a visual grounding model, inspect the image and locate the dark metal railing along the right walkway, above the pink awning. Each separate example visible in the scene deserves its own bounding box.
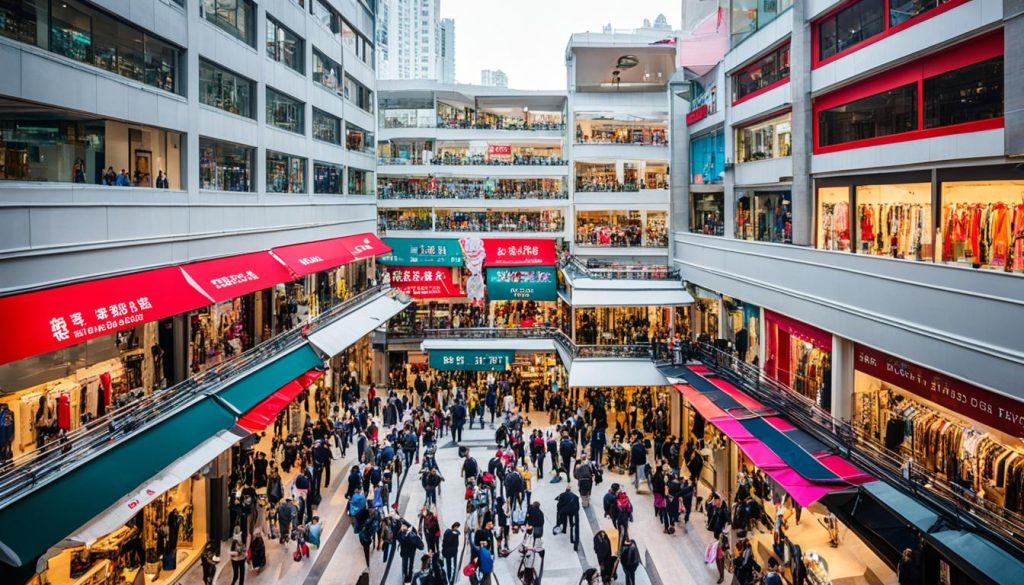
[690,342,1024,555]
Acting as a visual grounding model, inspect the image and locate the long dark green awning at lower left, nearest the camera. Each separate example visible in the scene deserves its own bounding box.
[0,396,234,566]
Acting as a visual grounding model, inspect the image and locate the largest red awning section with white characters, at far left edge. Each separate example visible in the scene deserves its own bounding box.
[0,266,210,364]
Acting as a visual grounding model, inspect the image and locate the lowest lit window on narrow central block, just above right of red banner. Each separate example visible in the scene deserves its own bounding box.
[575,209,669,248]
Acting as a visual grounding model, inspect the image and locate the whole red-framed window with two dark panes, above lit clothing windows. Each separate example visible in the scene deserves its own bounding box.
[814,29,1004,154]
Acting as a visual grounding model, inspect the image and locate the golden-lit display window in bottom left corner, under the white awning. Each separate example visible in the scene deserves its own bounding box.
[33,477,207,585]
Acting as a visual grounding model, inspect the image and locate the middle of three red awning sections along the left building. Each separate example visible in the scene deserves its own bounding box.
[181,252,292,302]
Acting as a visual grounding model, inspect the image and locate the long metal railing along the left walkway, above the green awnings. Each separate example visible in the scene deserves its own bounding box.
[0,285,385,508]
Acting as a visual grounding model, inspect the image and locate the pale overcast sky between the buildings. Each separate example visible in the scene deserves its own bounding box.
[441,0,682,89]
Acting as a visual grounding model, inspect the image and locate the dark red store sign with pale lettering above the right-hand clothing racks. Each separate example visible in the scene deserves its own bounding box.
[854,344,1024,437]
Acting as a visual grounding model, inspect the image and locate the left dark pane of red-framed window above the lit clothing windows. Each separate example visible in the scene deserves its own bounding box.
[818,83,918,147]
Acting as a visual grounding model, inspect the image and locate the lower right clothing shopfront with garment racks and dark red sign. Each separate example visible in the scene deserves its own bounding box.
[853,344,1024,514]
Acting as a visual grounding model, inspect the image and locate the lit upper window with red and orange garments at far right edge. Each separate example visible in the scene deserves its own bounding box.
[940,179,1024,274]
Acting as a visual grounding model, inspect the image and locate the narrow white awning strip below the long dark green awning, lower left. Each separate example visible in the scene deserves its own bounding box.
[45,426,249,568]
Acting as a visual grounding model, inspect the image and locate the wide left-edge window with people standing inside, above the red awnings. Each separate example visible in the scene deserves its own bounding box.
[0,99,183,190]
